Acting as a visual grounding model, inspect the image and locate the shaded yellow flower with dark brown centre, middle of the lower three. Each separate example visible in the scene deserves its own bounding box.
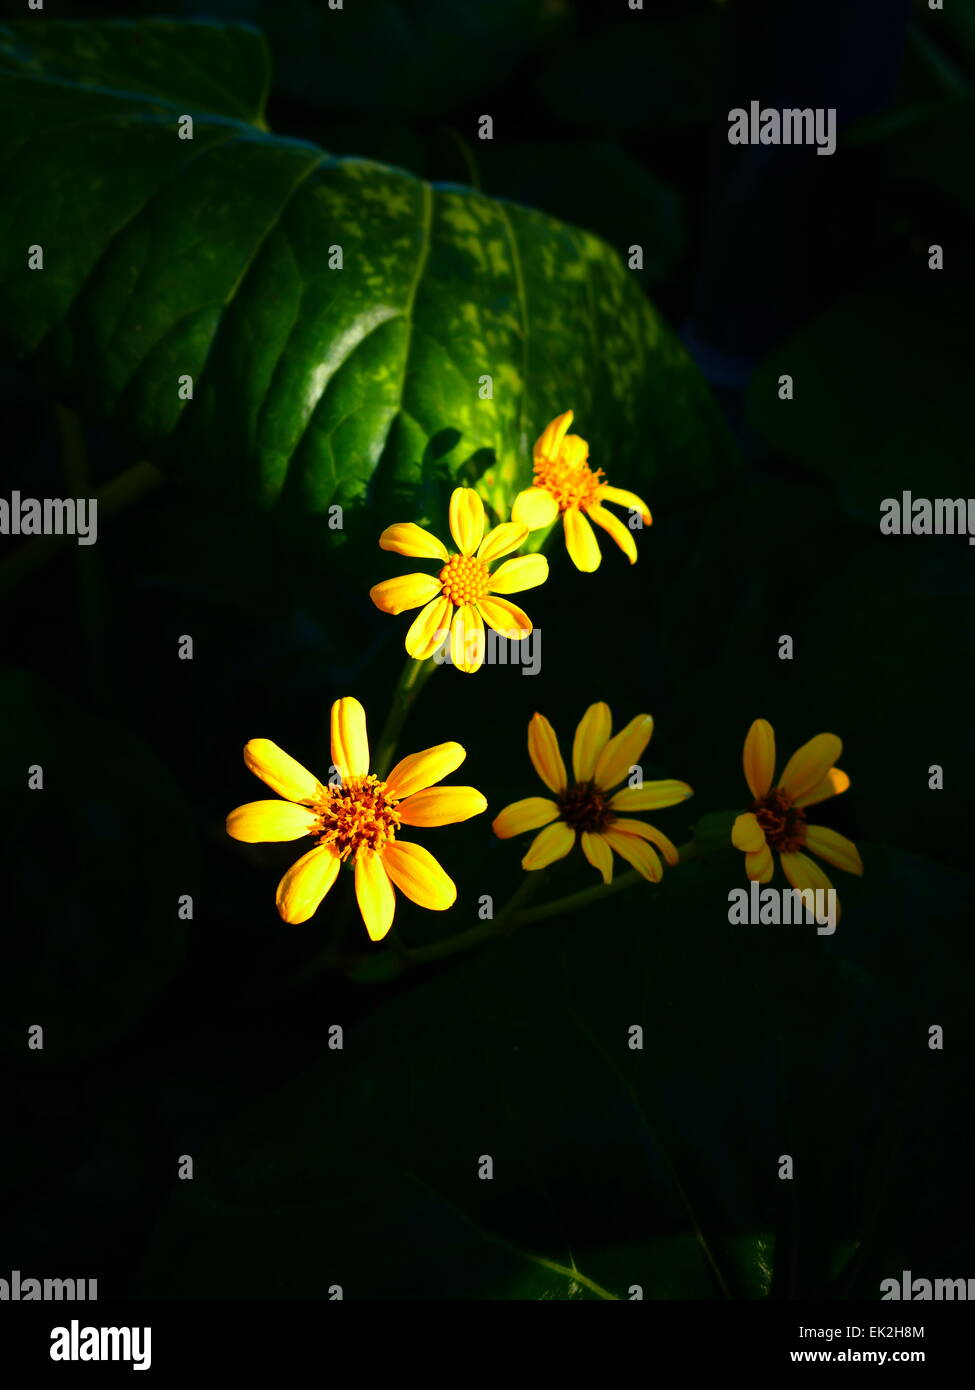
[492,702,693,883]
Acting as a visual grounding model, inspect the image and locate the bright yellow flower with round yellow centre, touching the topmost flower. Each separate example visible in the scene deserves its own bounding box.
[369,488,548,673]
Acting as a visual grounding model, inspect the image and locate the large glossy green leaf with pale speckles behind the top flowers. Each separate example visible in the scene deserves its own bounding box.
[0,21,725,558]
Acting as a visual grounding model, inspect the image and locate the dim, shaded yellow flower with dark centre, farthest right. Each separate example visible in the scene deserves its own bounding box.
[732,719,864,917]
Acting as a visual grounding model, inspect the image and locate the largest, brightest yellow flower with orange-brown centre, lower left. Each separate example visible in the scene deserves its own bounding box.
[227,696,487,941]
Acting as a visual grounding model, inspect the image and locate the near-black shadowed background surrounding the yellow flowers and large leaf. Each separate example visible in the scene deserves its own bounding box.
[0,0,975,1298]
